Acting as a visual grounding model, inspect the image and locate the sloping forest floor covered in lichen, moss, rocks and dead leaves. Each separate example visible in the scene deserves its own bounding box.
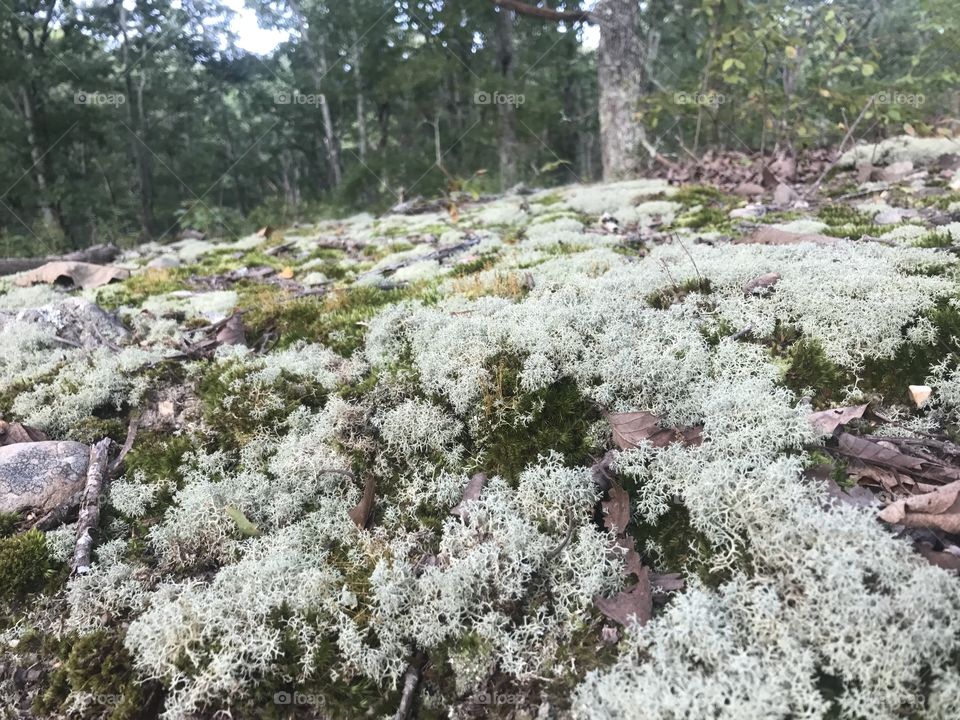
[0,138,960,720]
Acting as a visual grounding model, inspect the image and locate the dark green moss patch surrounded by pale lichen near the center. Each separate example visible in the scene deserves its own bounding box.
[473,356,599,479]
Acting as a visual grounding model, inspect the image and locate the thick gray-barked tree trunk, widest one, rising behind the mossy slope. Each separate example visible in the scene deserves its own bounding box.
[592,0,643,181]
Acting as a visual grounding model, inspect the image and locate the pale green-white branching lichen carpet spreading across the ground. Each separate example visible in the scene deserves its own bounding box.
[0,176,960,720]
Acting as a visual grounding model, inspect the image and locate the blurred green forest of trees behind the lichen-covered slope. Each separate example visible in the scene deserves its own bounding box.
[0,0,960,256]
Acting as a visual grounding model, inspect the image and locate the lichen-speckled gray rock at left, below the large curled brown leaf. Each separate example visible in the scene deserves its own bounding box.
[0,297,130,348]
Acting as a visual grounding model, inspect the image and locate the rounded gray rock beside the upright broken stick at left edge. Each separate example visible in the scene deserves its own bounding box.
[0,440,90,513]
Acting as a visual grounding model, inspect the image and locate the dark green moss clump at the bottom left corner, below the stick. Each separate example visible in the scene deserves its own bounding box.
[33,630,160,720]
